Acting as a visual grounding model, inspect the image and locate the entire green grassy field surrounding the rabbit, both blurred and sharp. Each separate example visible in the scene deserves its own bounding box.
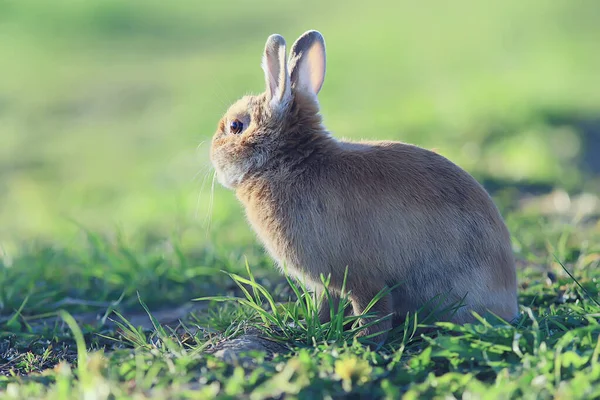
[0,0,600,399]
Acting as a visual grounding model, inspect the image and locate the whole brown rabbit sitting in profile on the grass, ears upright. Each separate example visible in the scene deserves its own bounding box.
[211,31,518,341]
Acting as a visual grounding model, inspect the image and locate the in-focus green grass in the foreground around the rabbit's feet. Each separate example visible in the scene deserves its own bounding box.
[0,219,600,399]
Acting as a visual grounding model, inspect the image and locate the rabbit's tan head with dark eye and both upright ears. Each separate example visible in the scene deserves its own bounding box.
[210,31,327,188]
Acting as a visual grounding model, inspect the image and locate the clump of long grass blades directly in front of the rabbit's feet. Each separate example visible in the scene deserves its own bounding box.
[195,262,476,347]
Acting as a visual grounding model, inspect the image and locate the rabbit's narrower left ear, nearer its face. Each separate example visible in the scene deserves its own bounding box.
[262,35,292,108]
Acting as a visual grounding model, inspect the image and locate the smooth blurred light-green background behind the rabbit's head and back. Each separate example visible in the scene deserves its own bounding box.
[0,0,600,247]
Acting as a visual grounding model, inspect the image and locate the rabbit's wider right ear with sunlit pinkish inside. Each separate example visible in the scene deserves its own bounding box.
[289,31,325,96]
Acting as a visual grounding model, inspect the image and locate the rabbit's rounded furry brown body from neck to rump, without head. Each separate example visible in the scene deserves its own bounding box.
[238,138,517,322]
